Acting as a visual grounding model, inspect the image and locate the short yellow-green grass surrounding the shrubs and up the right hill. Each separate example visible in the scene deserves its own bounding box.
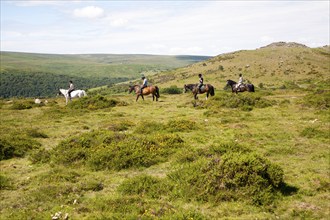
[0,43,330,219]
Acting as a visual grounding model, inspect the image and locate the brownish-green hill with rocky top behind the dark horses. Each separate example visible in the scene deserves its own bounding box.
[148,42,330,89]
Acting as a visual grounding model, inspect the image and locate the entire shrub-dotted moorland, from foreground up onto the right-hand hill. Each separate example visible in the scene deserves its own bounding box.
[0,42,330,219]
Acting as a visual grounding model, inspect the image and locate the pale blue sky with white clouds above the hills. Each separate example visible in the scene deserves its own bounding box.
[0,0,330,56]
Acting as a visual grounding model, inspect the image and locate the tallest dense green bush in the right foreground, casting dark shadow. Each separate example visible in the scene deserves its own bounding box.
[168,145,283,206]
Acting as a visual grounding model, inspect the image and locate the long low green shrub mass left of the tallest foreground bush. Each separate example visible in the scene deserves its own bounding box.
[52,131,183,170]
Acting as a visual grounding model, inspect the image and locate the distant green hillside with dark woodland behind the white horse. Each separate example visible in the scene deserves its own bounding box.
[0,51,210,97]
